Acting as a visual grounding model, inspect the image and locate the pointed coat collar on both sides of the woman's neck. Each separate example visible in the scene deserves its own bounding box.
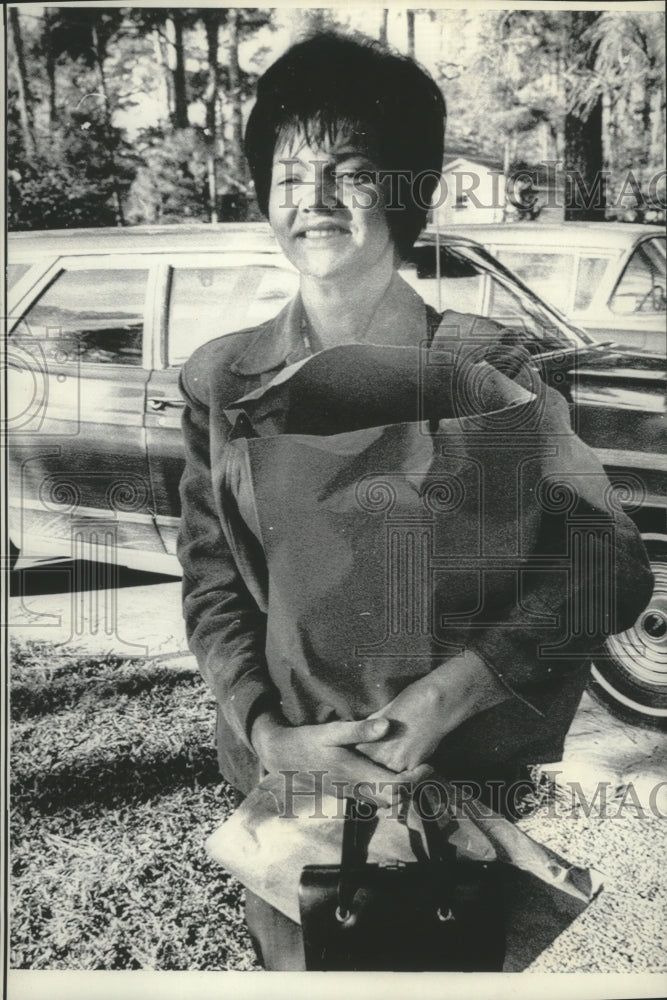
[230,272,428,375]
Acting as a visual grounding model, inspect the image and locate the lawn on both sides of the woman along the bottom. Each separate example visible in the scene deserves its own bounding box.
[10,642,667,973]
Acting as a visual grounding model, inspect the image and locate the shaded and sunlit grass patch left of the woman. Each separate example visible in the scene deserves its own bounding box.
[10,643,257,970]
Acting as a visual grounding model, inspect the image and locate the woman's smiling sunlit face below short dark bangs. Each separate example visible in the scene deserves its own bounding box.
[269,131,394,284]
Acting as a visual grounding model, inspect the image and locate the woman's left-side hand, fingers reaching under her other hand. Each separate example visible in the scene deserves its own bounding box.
[251,712,429,806]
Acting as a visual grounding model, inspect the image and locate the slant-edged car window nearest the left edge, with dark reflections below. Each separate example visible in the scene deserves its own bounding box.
[15,268,148,365]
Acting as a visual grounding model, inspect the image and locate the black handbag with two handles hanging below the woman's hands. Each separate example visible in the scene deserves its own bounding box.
[299,799,506,972]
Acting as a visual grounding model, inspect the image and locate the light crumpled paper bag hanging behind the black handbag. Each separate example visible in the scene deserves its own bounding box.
[206,776,602,972]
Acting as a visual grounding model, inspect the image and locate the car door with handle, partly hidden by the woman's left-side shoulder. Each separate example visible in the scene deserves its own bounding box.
[146,252,298,553]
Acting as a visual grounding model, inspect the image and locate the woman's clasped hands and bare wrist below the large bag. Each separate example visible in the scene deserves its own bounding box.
[251,652,509,805]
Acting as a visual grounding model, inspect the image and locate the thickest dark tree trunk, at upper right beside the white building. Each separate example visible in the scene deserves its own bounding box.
[565,10,606,222]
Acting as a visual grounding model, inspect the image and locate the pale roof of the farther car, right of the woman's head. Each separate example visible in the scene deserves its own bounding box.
[428,222,665,252]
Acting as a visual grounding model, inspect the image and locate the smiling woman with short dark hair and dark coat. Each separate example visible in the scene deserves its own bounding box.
[179,34,650,969]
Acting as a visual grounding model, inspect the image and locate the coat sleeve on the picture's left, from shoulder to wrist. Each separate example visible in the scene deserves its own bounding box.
[177,366,278,750]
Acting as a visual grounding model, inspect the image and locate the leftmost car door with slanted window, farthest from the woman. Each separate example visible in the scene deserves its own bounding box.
[8,255,162,562]
